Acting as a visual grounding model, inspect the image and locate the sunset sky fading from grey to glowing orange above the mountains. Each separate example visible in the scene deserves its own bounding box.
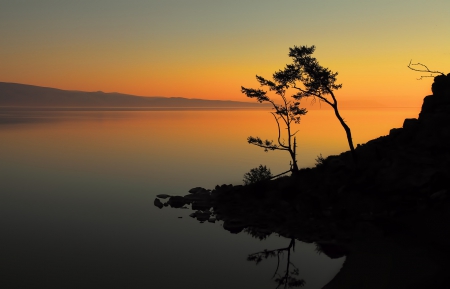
[0,0,450,107]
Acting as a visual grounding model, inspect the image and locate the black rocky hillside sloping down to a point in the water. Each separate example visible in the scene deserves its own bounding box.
[159,75,450,289]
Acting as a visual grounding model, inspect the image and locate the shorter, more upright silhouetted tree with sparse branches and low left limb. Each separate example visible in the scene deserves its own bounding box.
[241,74,307,172]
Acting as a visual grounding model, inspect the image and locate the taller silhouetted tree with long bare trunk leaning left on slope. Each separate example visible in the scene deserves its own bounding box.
[273,45,357,162]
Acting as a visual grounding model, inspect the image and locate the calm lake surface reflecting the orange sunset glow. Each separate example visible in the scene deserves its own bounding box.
[0,108,419,289]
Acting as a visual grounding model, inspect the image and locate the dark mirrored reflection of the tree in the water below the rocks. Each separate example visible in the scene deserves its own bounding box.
[247,238,306,289]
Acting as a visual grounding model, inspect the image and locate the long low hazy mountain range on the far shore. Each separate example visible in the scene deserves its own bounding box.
[0,82,268,108]
